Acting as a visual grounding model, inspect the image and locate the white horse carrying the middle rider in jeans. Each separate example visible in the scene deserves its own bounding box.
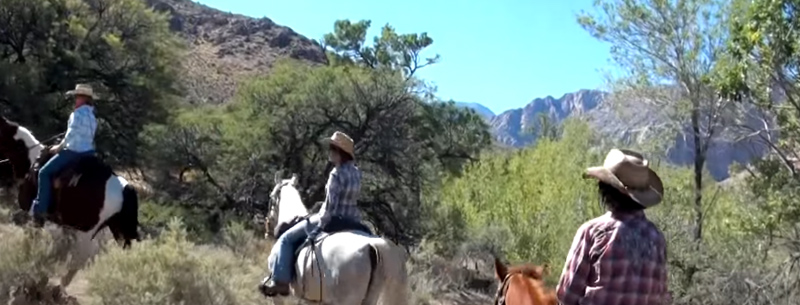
[265,173,409,305]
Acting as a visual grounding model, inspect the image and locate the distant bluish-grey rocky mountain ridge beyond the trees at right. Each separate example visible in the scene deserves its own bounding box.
[489,90,767,181]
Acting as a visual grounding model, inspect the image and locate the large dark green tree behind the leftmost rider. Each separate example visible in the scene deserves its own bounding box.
[0,0,181,164]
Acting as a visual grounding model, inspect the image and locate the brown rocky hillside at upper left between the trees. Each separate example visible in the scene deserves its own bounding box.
[146,0,327,103]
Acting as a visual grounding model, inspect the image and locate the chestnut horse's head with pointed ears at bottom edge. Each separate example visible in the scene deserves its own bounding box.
[494,257,558,305]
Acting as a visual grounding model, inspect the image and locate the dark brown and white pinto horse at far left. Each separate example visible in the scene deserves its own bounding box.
[0,118,139,288]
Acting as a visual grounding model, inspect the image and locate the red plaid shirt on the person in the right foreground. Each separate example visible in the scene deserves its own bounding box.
[556,211,671,305]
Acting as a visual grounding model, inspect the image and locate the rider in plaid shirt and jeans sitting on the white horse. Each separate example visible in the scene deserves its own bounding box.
[259,131,361,296]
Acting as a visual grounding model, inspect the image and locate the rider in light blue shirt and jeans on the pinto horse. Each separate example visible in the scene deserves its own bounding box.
[31,84,97,225]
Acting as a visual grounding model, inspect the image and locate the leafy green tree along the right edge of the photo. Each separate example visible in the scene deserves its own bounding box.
[716,0,800,288]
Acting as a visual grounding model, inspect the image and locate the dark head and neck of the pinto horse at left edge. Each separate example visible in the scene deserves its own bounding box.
[0,117,42,187]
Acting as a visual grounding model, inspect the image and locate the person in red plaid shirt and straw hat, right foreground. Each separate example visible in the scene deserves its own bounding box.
[556,149,671,305]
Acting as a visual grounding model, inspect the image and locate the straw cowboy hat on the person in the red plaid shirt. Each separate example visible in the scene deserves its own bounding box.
[583,148,664,208]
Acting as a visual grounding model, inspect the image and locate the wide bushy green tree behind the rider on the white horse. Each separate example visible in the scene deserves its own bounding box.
[145,60,490,244]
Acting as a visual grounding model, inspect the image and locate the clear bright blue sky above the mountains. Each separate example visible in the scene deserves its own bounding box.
[199,0,610,113]
